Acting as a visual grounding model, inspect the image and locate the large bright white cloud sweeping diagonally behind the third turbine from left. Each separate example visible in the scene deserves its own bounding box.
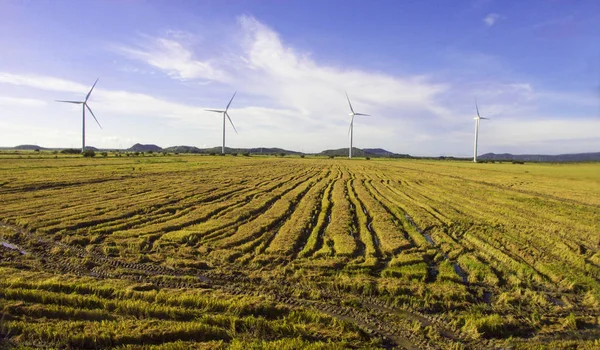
[112,16,448,126]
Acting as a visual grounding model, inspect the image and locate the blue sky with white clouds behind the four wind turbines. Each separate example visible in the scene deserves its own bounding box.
[0,0,600,156]
